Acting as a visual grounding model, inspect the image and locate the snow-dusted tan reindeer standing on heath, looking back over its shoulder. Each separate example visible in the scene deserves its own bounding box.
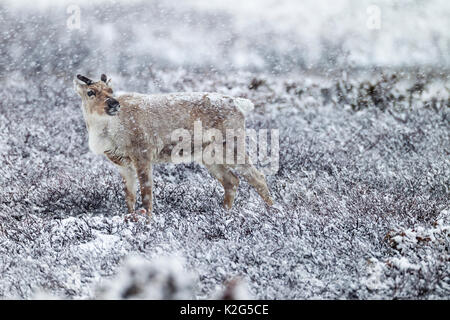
[74,74,273,219]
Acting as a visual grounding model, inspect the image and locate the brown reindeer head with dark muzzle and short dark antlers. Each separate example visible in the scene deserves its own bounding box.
[73,74,120,116]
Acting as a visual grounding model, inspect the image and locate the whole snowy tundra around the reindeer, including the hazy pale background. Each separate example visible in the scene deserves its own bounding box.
[0,1,450,299]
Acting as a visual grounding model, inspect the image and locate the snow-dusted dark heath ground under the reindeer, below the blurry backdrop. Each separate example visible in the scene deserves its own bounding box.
[0,72,450,299]
